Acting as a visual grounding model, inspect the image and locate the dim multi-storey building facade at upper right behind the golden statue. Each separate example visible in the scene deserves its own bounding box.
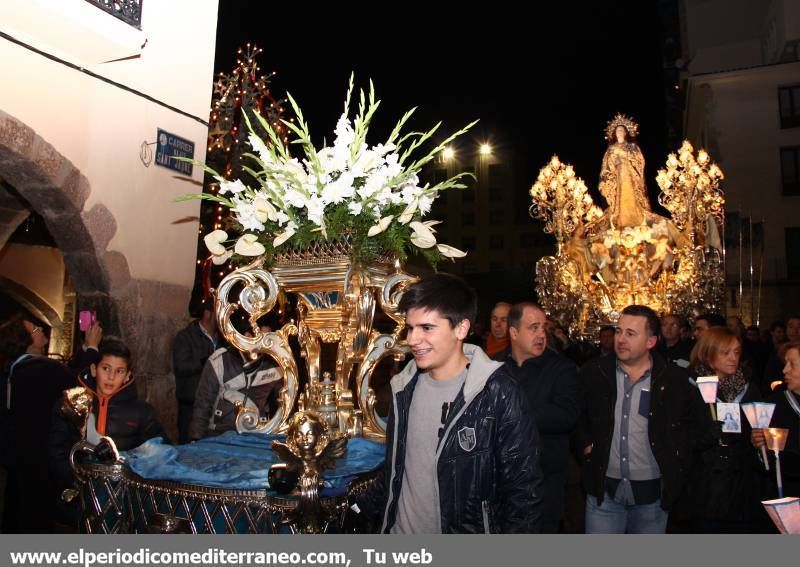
[681,0,800,326]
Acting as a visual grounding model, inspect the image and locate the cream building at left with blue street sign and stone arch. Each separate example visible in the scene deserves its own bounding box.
[0,0,218,438]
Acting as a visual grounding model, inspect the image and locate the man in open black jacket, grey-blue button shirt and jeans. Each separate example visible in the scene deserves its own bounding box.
[578,305,712,533]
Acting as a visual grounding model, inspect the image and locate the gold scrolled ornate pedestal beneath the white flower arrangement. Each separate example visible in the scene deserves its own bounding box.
[216,242,415,440]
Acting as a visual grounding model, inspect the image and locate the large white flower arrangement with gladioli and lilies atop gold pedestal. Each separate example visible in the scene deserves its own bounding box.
[179,76,477,264]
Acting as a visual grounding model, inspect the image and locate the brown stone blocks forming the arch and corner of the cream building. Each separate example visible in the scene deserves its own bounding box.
[0,111,191,439]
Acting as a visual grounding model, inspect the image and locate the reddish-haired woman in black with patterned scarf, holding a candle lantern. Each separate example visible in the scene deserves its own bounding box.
[689,327,759,533]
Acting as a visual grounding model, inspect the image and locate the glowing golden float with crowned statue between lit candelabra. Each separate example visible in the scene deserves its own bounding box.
[530,114,725,340]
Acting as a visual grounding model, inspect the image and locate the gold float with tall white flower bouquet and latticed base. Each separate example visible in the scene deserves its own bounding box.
[65,78,474,533]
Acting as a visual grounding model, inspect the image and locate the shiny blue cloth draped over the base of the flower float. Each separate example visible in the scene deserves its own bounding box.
[122,431,385,496]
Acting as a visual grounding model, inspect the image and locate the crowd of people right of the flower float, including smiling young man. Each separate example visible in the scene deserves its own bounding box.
[368,282,800,533]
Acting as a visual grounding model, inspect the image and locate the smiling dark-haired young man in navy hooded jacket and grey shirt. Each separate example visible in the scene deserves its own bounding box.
[381,274,542,534]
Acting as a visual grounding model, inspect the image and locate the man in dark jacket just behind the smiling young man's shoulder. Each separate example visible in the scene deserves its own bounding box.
[497,302,580,533]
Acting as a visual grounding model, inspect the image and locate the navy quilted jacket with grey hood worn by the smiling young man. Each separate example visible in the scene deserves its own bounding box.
[381,344,543,533]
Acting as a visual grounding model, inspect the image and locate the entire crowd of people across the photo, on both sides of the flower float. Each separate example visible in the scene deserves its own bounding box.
[0,282,800,534]
